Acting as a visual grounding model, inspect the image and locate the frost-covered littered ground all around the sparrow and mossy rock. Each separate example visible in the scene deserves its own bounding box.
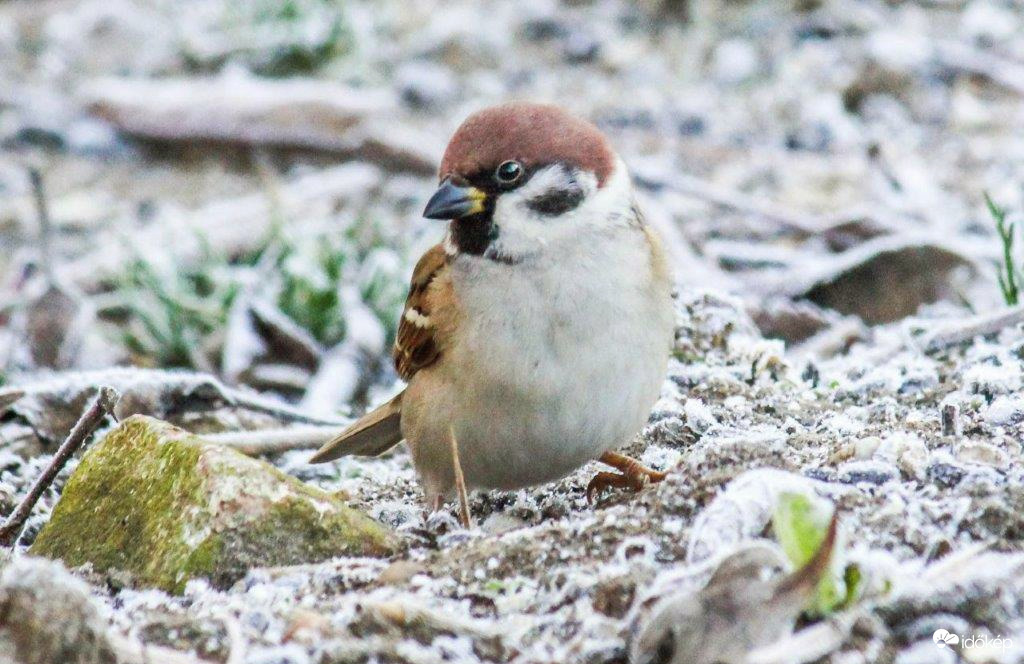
[0,0,1024,664]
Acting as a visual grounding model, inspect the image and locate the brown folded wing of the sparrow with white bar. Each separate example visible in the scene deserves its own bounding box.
[391,245,447,381]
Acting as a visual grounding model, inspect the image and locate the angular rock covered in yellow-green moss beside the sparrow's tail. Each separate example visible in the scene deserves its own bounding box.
[32,415,396,592]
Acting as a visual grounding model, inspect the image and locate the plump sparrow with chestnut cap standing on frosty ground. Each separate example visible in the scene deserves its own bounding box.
[310,101,675,523]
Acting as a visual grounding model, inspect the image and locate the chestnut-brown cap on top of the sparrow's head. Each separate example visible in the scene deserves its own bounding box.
[439,101,615,186]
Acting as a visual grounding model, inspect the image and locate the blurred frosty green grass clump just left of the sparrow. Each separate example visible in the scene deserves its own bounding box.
[116,221,406,370]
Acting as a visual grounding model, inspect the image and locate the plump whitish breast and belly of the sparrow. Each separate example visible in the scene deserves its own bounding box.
[445,226,672,488]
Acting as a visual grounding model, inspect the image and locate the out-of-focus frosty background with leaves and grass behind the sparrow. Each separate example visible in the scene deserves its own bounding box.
[0,0,1024,415]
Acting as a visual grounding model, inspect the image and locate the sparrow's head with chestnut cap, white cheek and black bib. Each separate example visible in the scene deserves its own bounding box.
[423,102,632,263]
